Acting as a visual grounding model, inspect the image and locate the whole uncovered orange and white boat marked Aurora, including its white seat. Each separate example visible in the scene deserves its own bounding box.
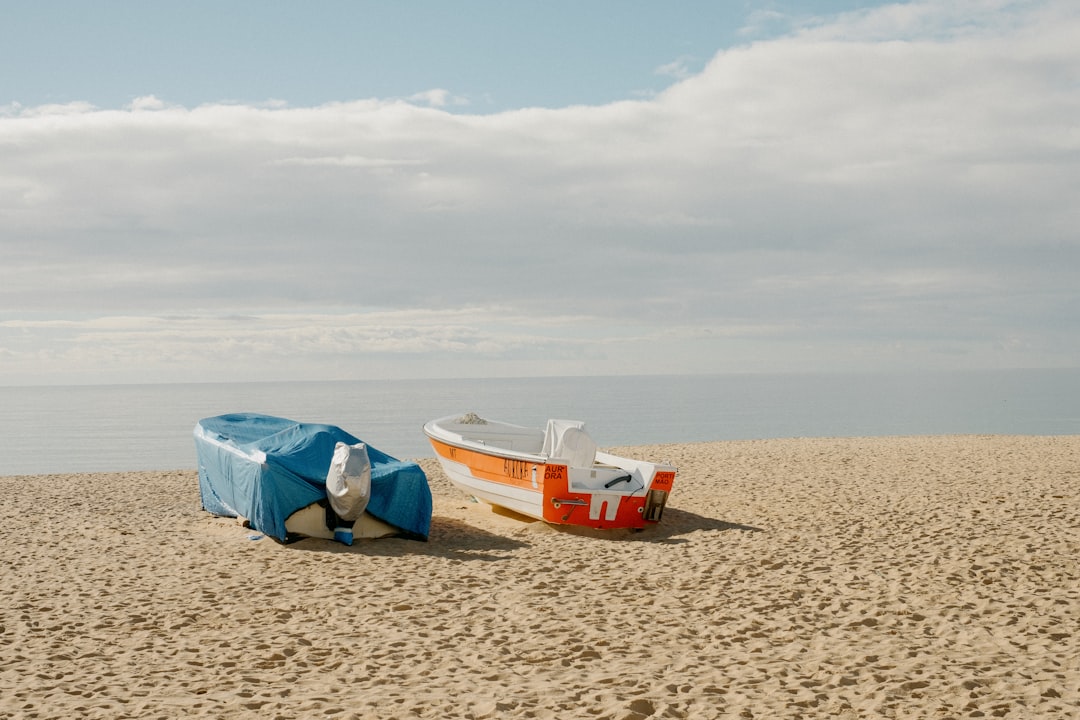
[423,412,676,529]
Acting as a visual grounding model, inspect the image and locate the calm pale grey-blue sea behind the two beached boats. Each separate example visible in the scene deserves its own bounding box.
[0,369,1080,475]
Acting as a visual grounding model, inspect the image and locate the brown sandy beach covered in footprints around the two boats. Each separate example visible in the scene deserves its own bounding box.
[0,436,1080,720]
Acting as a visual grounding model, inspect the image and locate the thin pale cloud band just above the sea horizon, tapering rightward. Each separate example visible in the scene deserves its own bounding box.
[0,307,759,382]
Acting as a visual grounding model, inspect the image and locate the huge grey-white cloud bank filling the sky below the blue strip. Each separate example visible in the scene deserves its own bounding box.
[0,0,1080,377]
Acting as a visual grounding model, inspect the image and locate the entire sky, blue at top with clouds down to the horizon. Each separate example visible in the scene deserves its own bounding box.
[0,0,1080,385]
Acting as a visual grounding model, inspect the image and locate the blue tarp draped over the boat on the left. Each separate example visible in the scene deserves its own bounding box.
[194,412,431,542]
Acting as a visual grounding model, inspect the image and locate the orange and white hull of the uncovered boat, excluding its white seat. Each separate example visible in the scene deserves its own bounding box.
[424,419,676,529]
